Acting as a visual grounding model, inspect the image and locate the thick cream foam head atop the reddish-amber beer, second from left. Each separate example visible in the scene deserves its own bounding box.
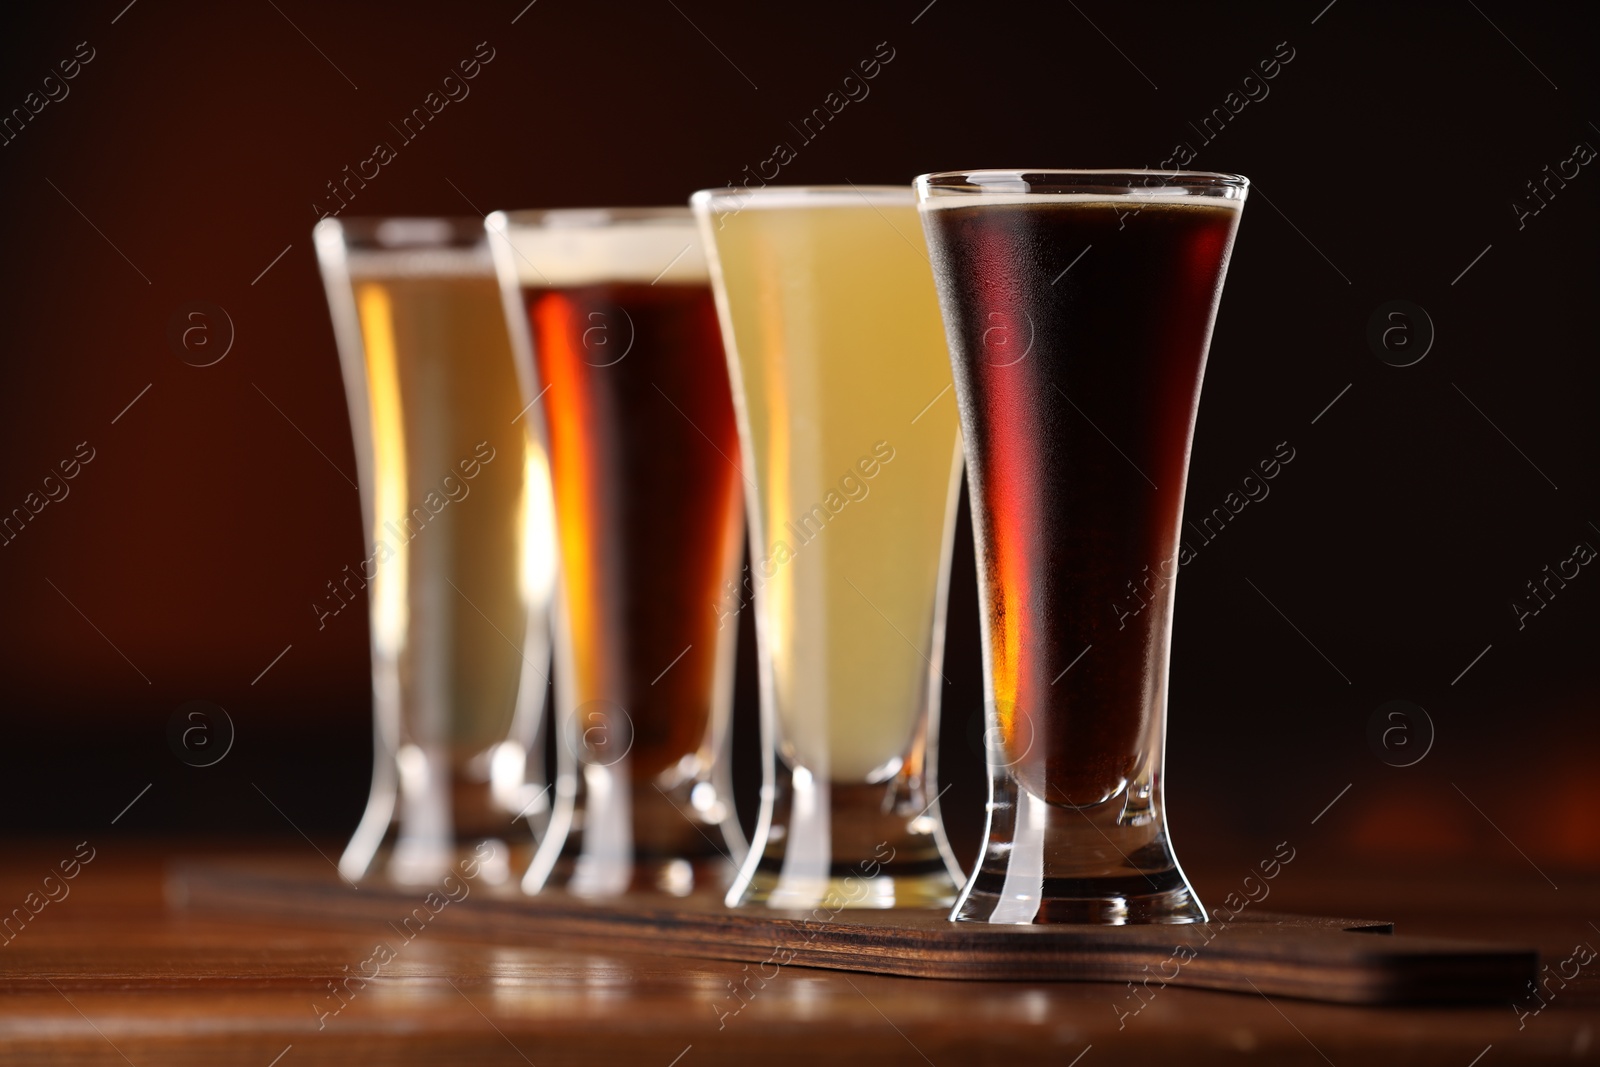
[488,208,710,286]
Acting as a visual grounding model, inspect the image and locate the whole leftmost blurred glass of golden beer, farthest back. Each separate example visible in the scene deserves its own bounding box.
[314,219,554,883]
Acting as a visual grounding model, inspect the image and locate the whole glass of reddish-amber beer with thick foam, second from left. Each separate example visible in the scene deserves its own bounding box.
[486,208,744,897]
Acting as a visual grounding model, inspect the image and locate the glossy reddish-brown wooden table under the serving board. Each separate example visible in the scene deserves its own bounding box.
[0,841,1600,1067]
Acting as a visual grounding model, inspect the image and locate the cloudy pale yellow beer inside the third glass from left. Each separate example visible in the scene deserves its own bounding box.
[712,198,958,782]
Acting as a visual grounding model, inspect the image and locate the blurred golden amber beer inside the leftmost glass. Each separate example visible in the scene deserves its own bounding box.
[350,250,552,758]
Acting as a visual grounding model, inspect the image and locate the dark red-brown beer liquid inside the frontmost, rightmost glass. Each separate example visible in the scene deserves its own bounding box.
[926,197,1238,805]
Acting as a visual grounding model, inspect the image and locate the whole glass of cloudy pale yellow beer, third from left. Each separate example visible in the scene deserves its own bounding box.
[693,187,960,909]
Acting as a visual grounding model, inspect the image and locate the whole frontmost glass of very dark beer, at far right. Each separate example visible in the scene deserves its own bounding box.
[917,171,1248,923]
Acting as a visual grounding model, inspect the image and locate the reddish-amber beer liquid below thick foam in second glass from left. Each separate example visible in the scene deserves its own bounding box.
[523,283,742,783]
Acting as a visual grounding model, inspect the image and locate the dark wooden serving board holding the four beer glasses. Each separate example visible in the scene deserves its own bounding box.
[168,859,1538,1005]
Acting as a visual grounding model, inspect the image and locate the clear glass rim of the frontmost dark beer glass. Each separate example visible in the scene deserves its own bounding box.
[912,168,1250,203]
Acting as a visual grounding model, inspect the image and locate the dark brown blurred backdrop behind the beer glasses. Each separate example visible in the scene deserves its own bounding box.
[0,0,1600,891]
